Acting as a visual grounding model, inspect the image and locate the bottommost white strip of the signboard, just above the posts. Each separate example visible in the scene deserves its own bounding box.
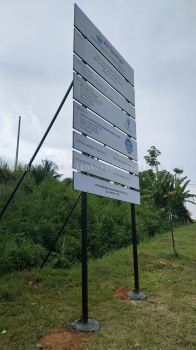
[73,172,140,204]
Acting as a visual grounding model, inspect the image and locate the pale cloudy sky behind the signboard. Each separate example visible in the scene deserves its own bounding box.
[0,0,196,215]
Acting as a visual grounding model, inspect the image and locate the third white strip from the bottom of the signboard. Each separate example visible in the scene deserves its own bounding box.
[73,131,138,175]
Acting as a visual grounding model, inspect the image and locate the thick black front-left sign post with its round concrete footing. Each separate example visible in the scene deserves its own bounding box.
[70,192,100,332]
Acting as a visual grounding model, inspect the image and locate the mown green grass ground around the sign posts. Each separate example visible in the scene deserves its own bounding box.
[0,224,196,350]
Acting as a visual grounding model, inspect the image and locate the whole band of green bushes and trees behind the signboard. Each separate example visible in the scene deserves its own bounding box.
[0,146,194,273]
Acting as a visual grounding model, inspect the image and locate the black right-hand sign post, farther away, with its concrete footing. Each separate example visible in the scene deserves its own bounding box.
[127,203,148,300]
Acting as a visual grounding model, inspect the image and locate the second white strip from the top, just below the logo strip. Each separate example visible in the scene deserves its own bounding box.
[74,29,135,110]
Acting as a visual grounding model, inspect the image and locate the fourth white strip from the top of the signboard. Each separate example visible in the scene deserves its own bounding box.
[73,73,136,139]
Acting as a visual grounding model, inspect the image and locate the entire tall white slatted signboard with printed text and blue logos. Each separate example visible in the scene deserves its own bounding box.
[73,5,140,204]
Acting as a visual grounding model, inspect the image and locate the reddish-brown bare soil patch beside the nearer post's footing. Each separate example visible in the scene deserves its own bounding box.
[40,328,91,350]
